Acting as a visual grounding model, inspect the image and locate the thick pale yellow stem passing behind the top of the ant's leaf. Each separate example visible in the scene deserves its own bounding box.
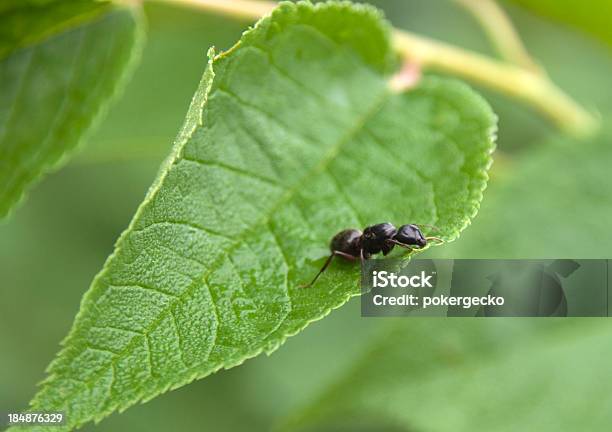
[152,0,599,137]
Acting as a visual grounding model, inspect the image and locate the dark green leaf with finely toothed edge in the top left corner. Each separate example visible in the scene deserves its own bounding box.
[0,1,142,218]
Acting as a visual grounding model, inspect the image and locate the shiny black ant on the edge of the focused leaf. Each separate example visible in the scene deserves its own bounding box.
[302,222,444,288]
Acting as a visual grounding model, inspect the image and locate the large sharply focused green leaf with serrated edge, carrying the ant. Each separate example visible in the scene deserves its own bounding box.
[22,3,495,429]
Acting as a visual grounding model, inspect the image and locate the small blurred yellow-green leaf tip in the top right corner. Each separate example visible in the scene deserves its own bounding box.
[510,0,612,46]
